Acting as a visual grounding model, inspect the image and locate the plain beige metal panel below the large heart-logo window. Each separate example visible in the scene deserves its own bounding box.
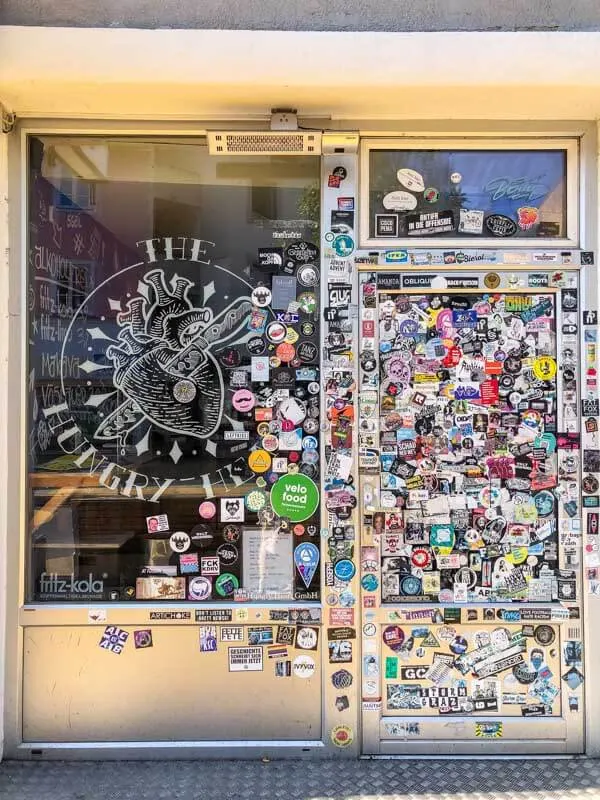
[23,625,321,742]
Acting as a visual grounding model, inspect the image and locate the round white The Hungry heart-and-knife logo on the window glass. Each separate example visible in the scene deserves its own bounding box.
[43,237,274,502]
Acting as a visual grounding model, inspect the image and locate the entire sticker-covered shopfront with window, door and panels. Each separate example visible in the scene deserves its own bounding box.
[2,18,600,758]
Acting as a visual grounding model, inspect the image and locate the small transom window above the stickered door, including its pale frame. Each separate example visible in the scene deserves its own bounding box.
[361,139,577,248]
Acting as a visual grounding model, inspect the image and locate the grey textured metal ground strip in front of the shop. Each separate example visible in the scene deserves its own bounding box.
[0,759,600,800]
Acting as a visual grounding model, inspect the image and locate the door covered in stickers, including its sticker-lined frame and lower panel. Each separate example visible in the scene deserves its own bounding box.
[359,268,584,754]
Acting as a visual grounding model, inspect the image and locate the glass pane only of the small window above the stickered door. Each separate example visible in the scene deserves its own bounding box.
[369,149,567,241]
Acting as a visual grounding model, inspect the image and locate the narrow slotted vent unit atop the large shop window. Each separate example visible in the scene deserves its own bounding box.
[208,131,321,156]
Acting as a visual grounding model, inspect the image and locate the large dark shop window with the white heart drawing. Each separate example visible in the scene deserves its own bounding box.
[27,136,320,602]
